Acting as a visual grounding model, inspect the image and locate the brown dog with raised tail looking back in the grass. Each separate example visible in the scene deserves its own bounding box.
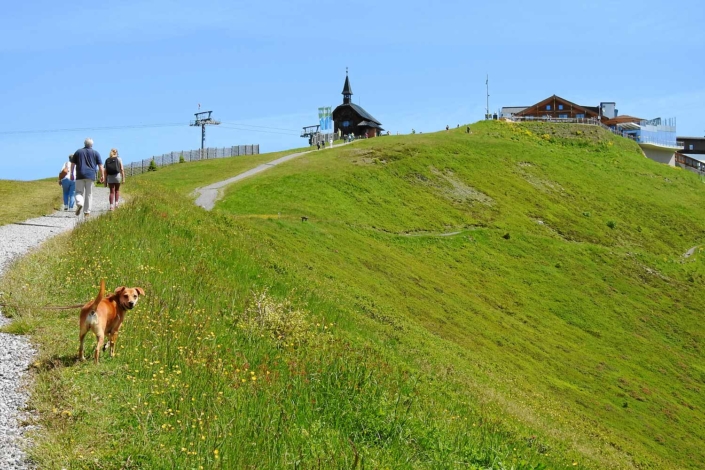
[78,279,144,364]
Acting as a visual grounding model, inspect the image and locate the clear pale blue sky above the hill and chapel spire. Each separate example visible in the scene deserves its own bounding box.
[0,0,705,180]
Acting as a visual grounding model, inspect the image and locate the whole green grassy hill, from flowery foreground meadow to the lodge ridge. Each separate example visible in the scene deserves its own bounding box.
[2,122,705,469]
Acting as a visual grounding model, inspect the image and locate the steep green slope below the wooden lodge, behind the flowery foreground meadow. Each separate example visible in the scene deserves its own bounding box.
[214,124,705,465]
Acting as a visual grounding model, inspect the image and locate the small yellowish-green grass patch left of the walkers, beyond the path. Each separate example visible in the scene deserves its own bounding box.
[0,178,62,225]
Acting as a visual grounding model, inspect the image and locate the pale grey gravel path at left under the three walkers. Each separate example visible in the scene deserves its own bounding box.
[0,186,109,470]
